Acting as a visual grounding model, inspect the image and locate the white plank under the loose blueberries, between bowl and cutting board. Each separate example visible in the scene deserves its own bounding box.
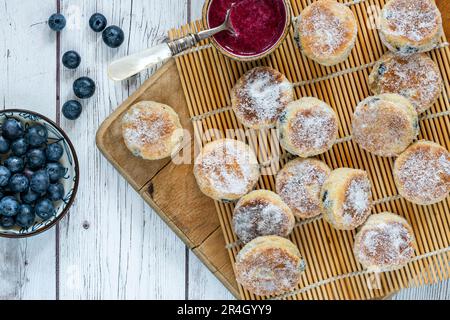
[60,0,187,299]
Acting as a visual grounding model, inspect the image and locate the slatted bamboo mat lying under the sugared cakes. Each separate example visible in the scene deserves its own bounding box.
[170,0,450,300]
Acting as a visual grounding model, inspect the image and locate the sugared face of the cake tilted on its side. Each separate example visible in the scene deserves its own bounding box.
[342,177,372,226]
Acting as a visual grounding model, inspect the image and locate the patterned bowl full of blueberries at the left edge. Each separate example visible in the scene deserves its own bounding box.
[0,109,79,238]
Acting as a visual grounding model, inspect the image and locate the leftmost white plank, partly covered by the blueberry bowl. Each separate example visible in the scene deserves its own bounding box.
[0,0,56,300]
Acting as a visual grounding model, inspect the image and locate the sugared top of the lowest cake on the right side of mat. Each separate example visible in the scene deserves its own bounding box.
[359,222,414,267]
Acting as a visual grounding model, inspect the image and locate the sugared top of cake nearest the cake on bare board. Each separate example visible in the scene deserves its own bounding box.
[196,140,258,194]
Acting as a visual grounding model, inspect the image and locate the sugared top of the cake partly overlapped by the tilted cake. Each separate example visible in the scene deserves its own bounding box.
[277,160,329,218]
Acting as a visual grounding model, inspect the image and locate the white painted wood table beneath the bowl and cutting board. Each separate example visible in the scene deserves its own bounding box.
[0,0,450,299]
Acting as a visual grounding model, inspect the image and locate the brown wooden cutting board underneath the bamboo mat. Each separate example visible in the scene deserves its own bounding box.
[96,0,450,298]
